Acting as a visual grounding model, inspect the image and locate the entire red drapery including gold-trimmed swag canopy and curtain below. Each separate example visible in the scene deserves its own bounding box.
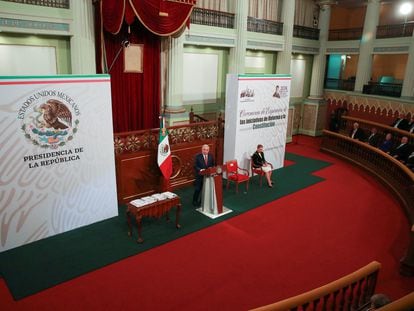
[95,0,195,133]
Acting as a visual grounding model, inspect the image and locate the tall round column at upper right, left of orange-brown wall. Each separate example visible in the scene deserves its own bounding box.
[355,0,380,92]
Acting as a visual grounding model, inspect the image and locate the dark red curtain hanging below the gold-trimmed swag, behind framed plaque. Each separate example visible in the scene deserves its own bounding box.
[104,22,161,133]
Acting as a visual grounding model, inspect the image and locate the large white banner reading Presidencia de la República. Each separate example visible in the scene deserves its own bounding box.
[0,75,118,252]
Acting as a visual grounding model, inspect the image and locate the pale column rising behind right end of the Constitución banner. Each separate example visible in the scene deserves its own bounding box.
[276,0,296,74]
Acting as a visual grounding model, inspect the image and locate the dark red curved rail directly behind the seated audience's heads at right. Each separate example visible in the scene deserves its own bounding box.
[340,116,414,145]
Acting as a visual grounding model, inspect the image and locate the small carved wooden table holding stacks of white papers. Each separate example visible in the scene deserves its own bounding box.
[126,196,181,243]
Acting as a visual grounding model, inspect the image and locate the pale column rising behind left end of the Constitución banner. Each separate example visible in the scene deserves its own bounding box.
[229,0,249,74]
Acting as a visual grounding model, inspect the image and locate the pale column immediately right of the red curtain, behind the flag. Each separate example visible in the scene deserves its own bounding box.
[161,34,188,126]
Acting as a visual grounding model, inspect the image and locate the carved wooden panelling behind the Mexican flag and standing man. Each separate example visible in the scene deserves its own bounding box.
[114,120,224,202]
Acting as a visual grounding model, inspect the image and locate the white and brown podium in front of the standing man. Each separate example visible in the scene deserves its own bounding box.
[196,165,232,219]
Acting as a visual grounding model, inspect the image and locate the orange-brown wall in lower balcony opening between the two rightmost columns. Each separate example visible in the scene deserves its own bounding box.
[372,54,408,82]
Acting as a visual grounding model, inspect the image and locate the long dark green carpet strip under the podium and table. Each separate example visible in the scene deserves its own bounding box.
[0,154,329,299]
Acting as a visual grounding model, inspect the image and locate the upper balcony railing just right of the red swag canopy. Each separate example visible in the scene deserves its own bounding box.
[190,8,234,28]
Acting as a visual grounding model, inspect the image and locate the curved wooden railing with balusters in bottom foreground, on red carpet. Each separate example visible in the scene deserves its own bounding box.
[249,261,381,311]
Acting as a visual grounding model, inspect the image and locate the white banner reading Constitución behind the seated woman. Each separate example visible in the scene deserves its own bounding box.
[224,74,291,169]
